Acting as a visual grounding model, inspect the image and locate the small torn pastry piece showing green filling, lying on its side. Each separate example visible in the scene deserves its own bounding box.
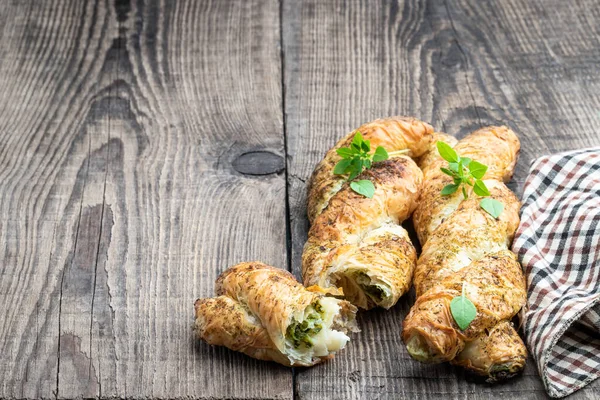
[194,262,358,366]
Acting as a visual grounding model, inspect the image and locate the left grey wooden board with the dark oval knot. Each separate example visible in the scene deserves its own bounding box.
[0,0,292,398]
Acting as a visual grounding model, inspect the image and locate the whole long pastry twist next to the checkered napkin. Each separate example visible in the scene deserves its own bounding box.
[402,127,527,381]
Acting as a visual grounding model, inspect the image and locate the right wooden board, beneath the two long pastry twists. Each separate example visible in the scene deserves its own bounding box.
[282,0,600,399]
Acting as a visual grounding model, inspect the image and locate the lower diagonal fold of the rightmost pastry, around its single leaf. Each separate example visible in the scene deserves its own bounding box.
[402,250,526,362]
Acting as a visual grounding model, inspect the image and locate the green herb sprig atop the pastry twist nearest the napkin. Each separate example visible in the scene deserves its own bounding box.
[436,141,504,218]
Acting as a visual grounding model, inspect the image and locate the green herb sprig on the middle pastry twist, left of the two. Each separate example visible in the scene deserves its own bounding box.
[333,131,406,198]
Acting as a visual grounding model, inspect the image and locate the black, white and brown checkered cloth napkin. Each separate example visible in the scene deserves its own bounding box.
[513,148,600,397]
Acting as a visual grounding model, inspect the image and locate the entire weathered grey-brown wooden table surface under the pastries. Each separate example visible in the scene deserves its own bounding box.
[0,0,600,399]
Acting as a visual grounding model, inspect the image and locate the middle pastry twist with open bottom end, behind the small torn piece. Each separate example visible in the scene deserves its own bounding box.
[302,117,433,309]
